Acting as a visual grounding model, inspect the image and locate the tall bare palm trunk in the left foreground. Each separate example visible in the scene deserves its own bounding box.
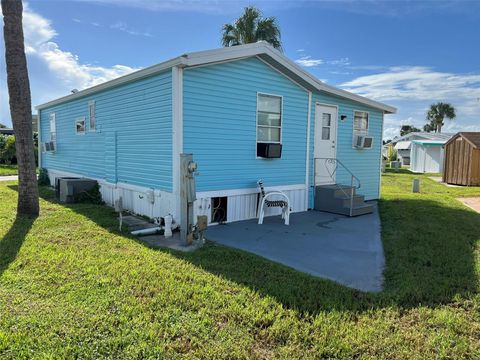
[2,0,39,216]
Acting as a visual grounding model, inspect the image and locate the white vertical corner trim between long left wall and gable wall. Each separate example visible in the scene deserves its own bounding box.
[172,66,183,221]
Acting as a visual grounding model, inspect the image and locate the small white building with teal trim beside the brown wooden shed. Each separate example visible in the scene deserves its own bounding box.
[410,140,446,173]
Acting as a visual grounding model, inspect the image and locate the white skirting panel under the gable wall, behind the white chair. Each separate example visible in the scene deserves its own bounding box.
[194,184,307,223]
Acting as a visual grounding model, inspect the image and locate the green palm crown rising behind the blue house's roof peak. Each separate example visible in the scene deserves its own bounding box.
[222,6,282,50]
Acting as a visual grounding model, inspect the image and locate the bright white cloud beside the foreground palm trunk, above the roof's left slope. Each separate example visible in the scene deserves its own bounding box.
[0,4,136,124]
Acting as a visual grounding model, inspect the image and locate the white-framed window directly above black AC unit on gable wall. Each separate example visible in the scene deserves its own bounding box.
[257,94,282,143]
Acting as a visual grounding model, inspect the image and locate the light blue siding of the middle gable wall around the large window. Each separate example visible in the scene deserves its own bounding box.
[183,58,308,191]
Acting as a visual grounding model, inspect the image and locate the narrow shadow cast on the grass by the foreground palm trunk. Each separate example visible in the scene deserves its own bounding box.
[0,216,36,277]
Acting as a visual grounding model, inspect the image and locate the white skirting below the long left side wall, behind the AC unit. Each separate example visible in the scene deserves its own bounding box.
[48,170,175,218]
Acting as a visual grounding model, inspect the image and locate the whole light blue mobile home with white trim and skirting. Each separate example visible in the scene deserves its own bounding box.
[37,42,396,222]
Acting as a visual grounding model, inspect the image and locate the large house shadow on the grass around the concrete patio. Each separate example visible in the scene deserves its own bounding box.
[29,189,480,313]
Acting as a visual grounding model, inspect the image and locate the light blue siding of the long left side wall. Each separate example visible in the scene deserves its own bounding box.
[40,70,172,191]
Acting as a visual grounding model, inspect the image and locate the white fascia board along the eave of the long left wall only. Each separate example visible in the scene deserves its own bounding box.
[35,56,184,110]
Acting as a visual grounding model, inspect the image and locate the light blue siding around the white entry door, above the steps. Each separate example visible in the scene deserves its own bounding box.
[309,92,383,206]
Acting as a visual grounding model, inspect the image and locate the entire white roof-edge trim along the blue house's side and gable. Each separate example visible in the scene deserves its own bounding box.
[36,41,397,113]
